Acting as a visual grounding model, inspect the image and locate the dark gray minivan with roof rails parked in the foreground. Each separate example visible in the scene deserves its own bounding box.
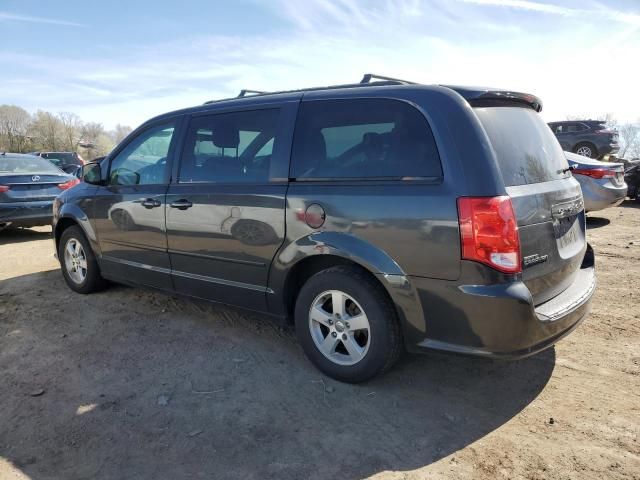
[54,75,596,382]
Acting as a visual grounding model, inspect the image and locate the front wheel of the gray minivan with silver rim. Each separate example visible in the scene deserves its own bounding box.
[58,226,106,294]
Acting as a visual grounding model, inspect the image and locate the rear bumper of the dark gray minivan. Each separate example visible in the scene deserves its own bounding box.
[405,247,596,359]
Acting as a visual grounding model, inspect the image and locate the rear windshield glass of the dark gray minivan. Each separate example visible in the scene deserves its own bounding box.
[474,107,570,187]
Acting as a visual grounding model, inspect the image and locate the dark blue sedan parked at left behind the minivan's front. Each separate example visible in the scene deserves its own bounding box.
[0,153,80,230]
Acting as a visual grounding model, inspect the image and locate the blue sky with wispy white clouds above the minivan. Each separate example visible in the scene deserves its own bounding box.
[0,0,640,128]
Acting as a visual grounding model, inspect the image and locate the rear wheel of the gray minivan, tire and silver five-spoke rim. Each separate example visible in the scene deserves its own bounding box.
[295,266,403,383]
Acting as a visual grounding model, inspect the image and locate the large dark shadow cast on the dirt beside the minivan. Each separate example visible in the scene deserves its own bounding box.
[0,271,555,480]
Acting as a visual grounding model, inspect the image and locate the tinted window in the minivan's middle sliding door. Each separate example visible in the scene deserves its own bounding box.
[178,109,279,183]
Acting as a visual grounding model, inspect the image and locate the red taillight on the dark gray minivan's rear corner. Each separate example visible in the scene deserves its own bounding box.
[458,195,522,273]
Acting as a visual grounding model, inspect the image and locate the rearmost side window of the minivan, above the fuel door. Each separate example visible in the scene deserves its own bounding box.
[291,99,442,179]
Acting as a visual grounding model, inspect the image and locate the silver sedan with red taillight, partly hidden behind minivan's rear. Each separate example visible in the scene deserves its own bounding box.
[564,152,627,212]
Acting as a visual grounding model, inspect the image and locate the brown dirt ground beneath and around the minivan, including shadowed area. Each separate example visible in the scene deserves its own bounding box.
[0,202,640,480]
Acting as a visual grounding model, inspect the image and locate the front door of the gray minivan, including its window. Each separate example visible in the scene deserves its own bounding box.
[94,121,176,289]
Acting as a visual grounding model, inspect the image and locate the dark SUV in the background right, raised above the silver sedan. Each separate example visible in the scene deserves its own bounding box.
[549,120,620,158]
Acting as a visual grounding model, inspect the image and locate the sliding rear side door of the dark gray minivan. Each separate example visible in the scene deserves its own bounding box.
[166,105,295,310]
